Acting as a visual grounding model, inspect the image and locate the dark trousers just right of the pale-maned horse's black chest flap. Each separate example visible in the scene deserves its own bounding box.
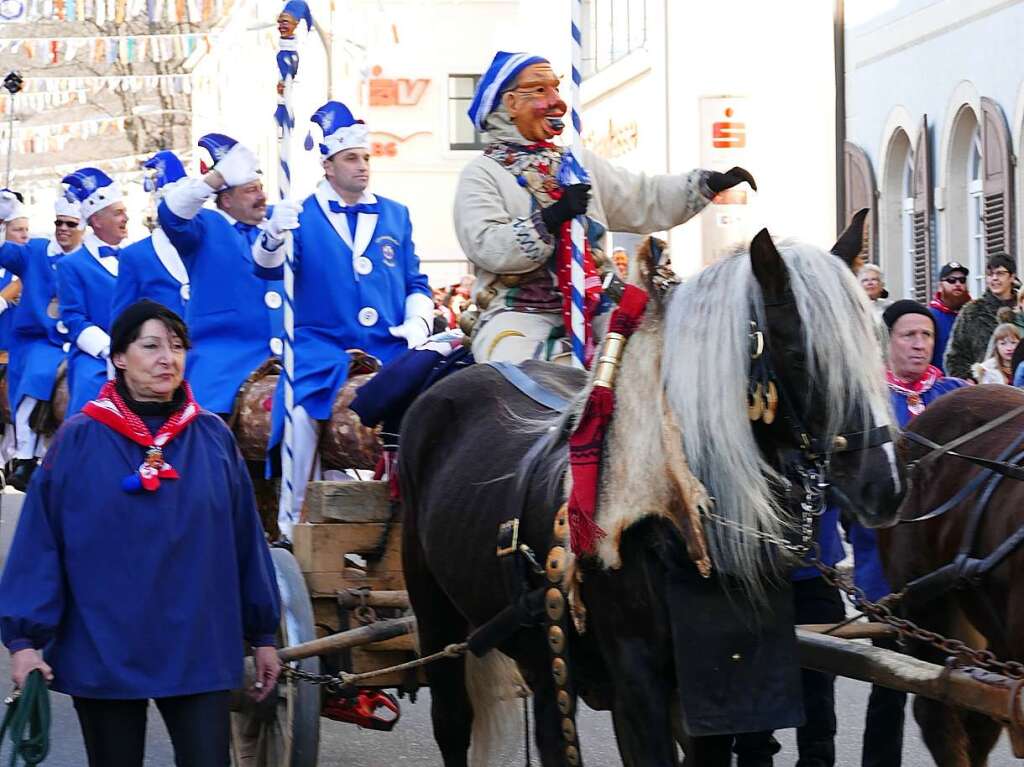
[732,578,846,767]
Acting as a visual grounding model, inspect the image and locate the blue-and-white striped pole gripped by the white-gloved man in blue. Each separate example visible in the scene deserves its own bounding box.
[274,29,299,540]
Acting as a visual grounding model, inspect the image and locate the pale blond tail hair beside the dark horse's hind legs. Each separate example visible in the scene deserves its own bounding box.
[466,650,527,767]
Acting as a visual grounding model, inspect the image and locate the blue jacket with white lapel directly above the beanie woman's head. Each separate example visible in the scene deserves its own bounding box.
[111,229,188,321]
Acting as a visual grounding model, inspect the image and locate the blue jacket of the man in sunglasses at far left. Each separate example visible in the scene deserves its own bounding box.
[0,239,68,409]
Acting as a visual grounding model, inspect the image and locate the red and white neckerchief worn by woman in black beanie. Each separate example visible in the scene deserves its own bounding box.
[82,381,200,493]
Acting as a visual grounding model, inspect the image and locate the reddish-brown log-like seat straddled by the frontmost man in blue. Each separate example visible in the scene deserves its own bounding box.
[228,349,381,469]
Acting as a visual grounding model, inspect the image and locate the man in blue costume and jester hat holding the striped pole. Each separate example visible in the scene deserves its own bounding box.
[253,101,434,537]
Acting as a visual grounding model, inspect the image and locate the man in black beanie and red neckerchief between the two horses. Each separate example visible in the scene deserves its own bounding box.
[849,300,968,767]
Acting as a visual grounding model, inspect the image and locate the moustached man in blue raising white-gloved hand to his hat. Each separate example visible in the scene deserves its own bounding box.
[157,133,284,415]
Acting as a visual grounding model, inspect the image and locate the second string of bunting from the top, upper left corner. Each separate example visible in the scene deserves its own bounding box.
[0,32,213,67]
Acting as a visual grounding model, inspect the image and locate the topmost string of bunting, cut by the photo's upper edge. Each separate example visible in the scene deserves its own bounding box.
[0,0,233,26]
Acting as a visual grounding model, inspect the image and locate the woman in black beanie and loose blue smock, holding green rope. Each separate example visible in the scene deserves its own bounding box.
[0,301,280,767]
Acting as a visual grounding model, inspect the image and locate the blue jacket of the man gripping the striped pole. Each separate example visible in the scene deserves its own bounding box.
[256,181,431,444]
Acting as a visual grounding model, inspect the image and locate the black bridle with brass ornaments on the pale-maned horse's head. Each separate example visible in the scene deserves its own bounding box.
[746,297,893,543]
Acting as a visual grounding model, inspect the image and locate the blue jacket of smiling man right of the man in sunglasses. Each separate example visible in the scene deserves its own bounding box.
[57,238,117,416]
